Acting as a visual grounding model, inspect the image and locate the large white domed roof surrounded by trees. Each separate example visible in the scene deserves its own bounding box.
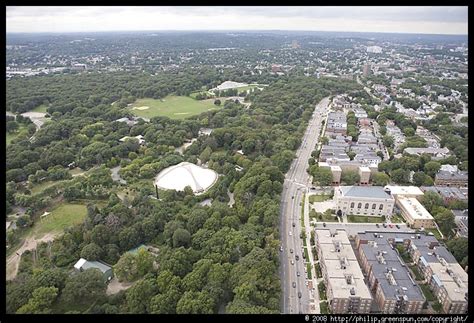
[155,162,217,194]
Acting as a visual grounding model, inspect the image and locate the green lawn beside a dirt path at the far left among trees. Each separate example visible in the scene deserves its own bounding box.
[34,202,87,238]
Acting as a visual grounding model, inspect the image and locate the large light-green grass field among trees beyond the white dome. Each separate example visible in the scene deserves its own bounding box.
[132,95,220,119]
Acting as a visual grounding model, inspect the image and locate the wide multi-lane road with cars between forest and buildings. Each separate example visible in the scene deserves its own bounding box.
[280,98,329,314]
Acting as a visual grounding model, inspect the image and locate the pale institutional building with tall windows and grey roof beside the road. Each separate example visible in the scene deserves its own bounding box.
[334,186,395,216]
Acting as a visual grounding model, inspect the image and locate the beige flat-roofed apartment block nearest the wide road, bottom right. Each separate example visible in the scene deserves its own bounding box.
[315,229,372,314]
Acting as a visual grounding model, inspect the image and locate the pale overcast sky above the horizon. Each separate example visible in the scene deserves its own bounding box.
[7,6,468,35]
